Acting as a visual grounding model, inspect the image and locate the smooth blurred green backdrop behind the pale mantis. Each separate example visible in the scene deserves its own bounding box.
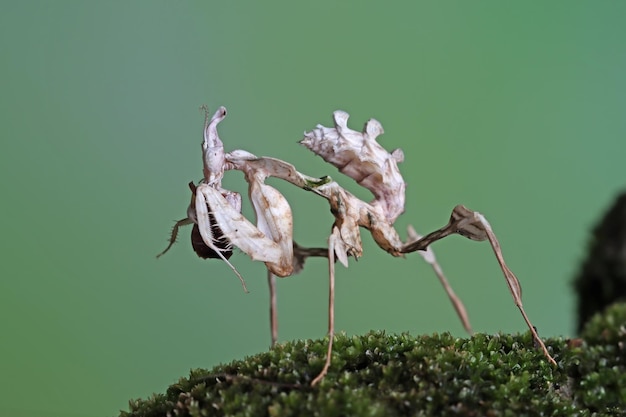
[0,1,626,417]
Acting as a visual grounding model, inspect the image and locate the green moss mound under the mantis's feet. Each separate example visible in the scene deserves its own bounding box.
[121,304,626,417]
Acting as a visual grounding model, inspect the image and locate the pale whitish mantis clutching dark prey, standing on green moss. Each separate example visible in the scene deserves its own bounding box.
[157,106,556,386]
